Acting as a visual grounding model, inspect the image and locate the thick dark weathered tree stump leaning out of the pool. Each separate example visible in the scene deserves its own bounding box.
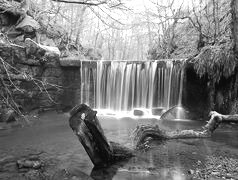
[69,104,133,166]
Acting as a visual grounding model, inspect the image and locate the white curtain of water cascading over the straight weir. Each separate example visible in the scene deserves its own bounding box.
[81,60,183,116]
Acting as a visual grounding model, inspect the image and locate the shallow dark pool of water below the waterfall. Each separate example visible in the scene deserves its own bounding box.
[0,112,238,180]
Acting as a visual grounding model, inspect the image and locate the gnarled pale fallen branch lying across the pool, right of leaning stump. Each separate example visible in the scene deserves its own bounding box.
[134,111,238,148]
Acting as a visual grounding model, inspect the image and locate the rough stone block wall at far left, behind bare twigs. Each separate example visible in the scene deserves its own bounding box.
[0,39,63,111]
